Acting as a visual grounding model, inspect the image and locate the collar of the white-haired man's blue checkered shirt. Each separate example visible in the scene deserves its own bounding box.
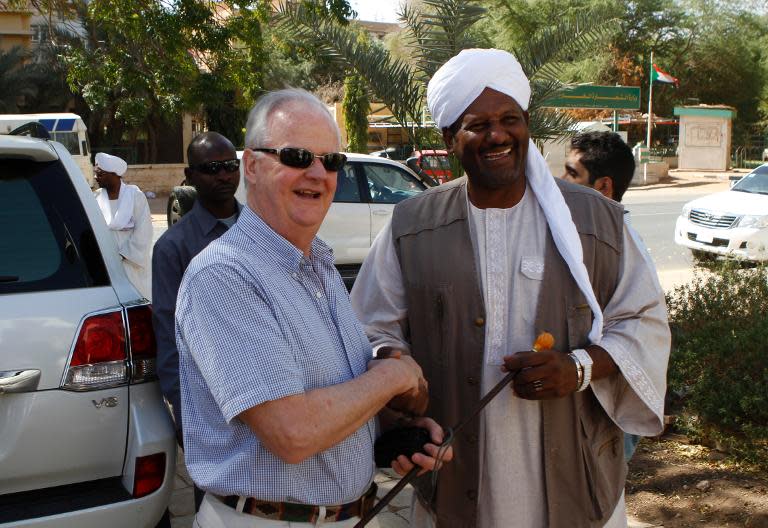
[235,205,333,270]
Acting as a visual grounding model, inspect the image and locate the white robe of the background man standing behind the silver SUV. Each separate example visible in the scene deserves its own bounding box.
[94,182,152,300]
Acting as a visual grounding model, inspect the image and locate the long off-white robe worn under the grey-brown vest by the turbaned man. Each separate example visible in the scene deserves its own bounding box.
[351,184,669,528]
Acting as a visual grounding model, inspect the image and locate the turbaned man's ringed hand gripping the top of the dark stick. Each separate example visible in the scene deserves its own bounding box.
[503,349,578,400]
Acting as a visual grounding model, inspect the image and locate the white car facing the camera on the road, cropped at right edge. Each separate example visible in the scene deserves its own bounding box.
[675,163,768,261]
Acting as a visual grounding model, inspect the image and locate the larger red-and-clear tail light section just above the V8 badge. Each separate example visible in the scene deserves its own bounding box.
[62,310,128,390]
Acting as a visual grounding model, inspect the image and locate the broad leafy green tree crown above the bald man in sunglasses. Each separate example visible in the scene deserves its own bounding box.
[64,0,268,161]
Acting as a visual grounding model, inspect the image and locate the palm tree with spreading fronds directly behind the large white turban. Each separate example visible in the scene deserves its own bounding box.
[276,0,618,148]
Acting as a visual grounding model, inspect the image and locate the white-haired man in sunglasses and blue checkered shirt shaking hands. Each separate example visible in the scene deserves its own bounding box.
[176,89,452,528]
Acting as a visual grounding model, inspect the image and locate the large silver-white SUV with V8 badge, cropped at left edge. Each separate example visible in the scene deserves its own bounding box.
[0,135,176,528]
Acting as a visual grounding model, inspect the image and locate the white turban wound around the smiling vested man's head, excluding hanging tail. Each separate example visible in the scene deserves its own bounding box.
[427,49,531,129]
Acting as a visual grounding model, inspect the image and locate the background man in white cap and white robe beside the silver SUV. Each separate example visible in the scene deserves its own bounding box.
[94,152,152,300]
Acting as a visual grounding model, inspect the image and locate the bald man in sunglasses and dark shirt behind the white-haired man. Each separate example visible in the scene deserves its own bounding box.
[152,132,242,458]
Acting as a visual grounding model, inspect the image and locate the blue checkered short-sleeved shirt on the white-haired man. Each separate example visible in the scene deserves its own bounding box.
[176,203,376,505]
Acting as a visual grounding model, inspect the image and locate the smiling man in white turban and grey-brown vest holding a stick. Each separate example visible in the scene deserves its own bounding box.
[352,49,670,528]
